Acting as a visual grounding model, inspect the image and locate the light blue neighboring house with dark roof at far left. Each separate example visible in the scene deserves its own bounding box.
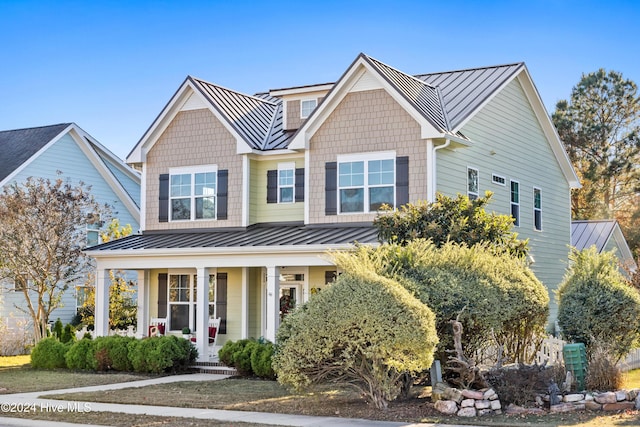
[0,123,140,326]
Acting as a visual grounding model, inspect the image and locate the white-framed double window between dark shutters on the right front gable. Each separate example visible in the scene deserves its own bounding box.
[338,153,395,213]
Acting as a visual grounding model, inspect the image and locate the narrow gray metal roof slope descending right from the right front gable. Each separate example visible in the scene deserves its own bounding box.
[362,54,449,132]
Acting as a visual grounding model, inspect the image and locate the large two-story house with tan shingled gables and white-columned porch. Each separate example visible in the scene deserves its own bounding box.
[88,54,579,358]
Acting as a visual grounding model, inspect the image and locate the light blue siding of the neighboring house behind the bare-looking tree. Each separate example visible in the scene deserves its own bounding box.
[0,134,140,323]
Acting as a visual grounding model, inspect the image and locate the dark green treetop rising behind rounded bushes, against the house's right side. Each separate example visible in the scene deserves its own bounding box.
[373,191,529,258]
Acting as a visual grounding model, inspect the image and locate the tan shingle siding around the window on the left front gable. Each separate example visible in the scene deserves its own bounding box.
[145,109,242,230]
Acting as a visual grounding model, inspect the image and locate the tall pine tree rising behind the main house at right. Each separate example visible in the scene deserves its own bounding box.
[552,69,640,254]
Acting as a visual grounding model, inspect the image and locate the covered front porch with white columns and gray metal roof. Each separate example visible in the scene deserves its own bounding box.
[87,225,377,361]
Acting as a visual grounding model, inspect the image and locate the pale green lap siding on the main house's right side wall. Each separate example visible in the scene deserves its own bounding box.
[436,80,571,319]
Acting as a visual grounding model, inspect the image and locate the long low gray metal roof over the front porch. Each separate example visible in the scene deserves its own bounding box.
[88,224,378,251]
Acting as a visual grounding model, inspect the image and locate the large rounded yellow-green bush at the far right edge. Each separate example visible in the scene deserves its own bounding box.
[557,247,640,362]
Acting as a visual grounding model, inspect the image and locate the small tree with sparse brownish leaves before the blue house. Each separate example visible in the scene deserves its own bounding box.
[0,178,109,342]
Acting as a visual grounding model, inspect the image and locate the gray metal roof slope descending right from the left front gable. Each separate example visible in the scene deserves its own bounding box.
[189,77,290,150]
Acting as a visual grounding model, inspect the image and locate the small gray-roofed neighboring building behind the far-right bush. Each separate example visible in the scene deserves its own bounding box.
[571,219,637,274]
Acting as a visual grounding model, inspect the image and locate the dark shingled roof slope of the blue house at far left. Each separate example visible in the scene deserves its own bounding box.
[0,123,71,181]
